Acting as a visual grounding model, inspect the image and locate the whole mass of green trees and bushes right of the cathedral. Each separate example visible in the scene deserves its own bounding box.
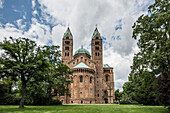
[124,0,170,106]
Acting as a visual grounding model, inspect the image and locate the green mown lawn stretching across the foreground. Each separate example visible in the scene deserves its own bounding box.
[0,105,169,113]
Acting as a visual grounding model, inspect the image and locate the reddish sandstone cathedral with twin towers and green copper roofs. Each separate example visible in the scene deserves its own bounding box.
[59,27,115,104]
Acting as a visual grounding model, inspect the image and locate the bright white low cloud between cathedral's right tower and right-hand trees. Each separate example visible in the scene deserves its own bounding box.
[103,45,139,90]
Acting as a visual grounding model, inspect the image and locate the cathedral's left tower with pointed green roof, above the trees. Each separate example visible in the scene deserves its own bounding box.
[62,27,73,64]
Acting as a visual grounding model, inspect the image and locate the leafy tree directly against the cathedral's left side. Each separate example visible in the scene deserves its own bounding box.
[43,45,72,101]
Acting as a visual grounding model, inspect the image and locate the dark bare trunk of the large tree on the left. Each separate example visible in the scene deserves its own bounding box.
[19,76,26,108]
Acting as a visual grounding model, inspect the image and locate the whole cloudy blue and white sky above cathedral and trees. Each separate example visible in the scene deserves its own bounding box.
[0,0,154,90]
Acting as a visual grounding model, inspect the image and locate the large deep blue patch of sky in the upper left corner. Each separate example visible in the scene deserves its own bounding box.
[0,0,32,30]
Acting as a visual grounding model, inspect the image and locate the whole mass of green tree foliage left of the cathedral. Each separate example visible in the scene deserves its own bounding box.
[0,37,72,108]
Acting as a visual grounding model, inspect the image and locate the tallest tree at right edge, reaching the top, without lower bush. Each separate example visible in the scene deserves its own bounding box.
[130,0,170,106]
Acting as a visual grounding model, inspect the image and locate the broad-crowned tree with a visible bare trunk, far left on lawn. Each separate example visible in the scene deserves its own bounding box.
[0,37,49,108]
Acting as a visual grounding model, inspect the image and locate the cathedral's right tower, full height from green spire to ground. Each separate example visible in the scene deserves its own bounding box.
[91,27,104,104]
